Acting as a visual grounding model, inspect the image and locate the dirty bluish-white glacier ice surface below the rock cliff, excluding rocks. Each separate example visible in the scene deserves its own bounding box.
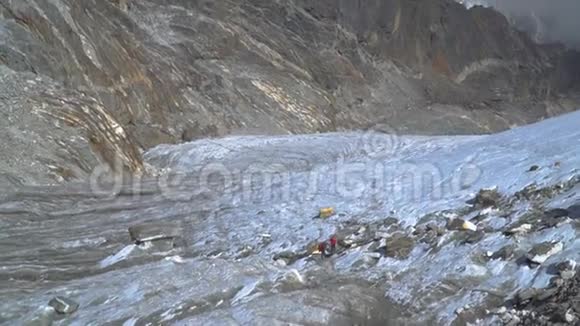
[0,113,580,325]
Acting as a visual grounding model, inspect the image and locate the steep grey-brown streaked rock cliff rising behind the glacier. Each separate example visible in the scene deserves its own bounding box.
[0,0,580,182]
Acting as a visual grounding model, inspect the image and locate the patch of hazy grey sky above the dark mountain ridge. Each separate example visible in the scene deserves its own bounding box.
[460,0,580,49]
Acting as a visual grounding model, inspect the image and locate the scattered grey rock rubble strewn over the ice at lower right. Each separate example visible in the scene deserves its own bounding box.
[275,185,580,326]
